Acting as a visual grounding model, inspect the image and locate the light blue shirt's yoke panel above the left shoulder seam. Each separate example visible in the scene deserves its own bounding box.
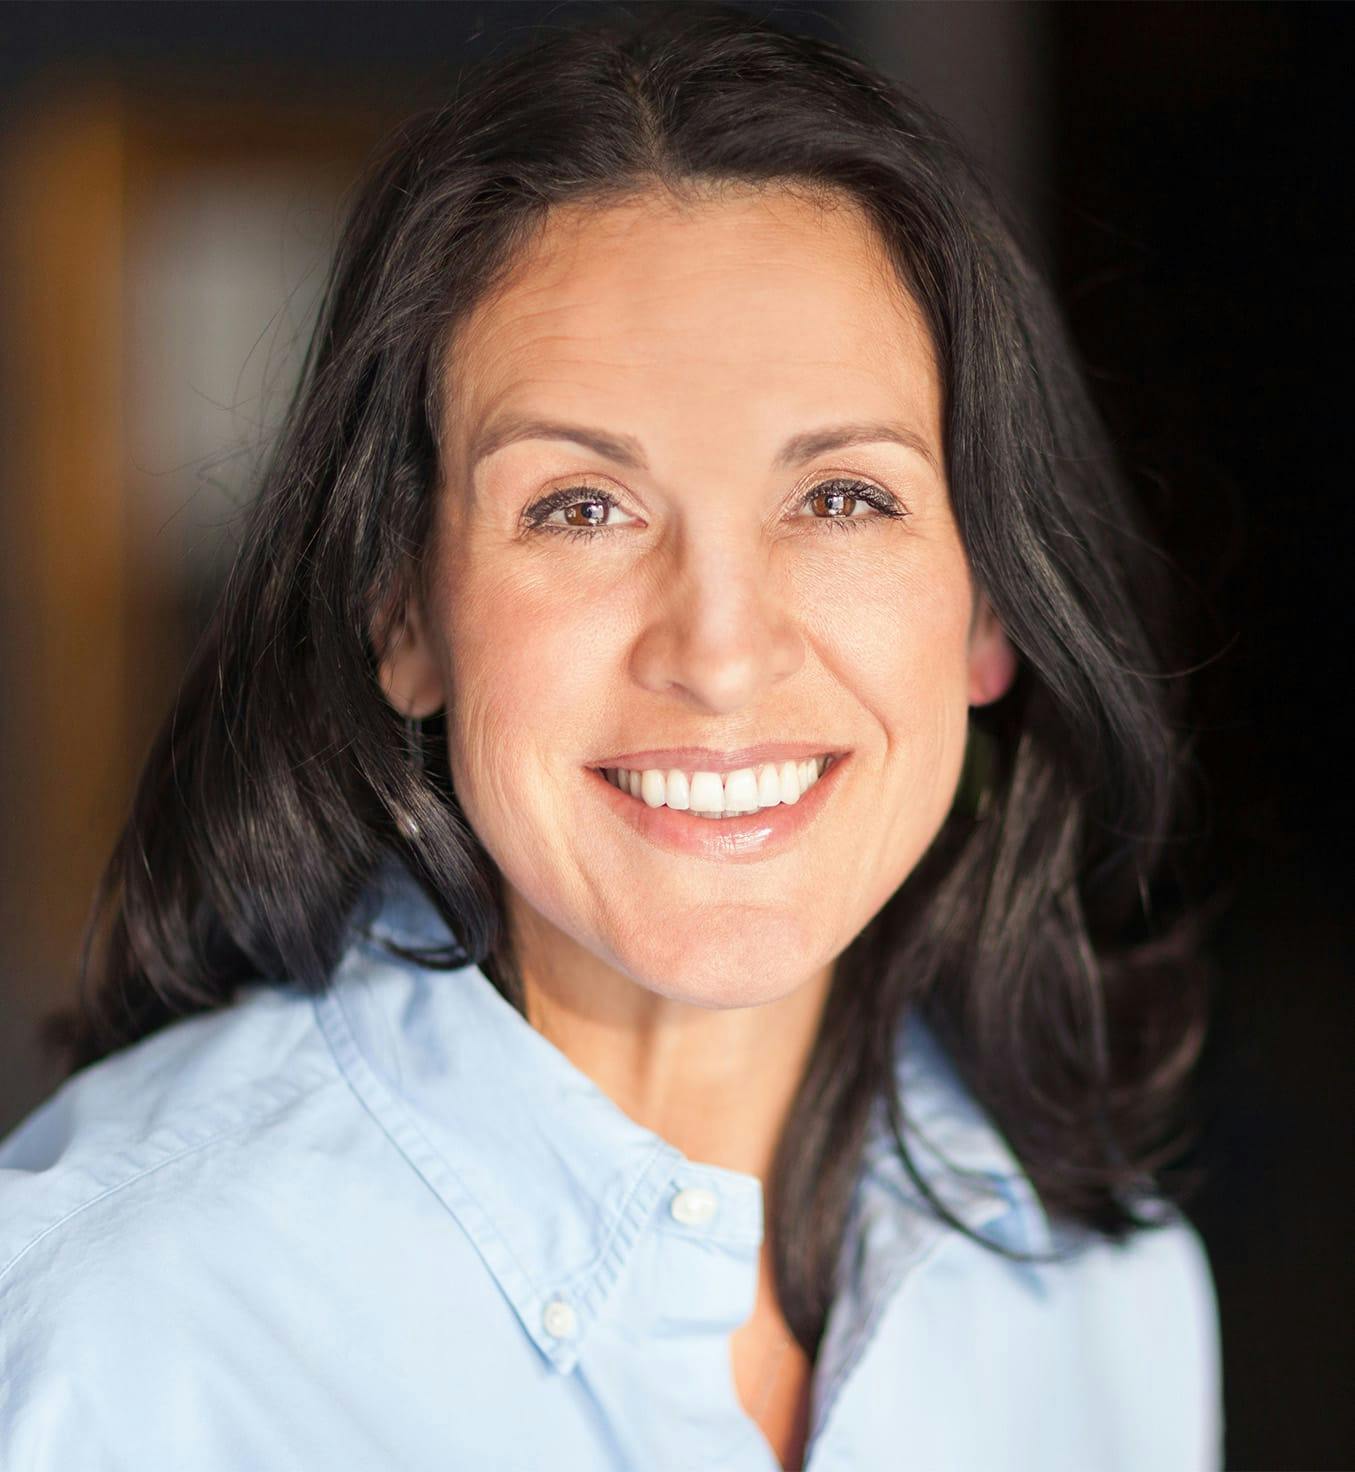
[0,985,341,1292]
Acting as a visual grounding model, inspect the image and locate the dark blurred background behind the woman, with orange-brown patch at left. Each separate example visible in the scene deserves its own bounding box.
[0,0,1355,1469]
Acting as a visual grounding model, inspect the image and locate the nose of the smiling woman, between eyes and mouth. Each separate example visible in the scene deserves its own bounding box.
[631,540,805,714]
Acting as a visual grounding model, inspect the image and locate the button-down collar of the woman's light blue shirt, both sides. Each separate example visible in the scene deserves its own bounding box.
[315,860,1049,1370]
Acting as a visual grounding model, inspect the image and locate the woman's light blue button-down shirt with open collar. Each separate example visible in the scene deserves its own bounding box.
[0,866,1223,1472]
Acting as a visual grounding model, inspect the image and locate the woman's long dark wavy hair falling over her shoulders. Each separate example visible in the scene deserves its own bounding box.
[44,4,1211,1371]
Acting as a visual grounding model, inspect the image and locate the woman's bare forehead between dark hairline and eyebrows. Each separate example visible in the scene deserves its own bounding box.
[447,190,940,449]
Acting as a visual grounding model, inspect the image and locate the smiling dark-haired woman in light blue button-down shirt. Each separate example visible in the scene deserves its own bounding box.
[0,6,1221,1472]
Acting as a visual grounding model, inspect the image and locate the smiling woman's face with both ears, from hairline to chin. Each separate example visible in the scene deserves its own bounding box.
[383,191,1014,1007]
